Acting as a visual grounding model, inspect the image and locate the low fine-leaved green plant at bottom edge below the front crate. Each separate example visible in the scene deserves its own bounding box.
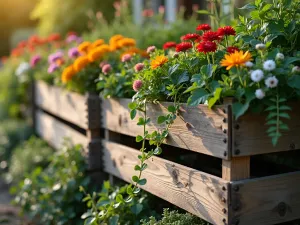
[141,209,209,225]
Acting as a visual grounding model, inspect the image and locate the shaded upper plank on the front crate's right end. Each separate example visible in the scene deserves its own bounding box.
[232,104,300,157]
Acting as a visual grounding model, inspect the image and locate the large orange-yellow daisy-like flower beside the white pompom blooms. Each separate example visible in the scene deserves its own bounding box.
[221,51,252,70]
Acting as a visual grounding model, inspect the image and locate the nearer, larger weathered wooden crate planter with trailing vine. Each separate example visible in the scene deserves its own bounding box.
[101,99,300,225]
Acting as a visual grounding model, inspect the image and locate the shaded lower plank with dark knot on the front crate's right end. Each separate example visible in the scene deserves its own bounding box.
[231,172,300,225]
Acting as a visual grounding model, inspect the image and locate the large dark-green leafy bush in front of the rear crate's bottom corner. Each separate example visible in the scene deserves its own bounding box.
[12,141,89,225]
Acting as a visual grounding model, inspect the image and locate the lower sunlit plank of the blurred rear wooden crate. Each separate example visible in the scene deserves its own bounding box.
[36,110,88,151]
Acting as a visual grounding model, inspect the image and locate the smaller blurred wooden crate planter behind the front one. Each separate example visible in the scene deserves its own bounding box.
[34,81,101,170]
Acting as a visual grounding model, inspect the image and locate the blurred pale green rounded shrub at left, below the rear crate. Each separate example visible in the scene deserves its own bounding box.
[9,136,54,183]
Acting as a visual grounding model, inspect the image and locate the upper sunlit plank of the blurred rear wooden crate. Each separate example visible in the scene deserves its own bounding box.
[35,81,88,129]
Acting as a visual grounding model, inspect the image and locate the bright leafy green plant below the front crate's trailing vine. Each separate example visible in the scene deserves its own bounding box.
[81,181,155,225]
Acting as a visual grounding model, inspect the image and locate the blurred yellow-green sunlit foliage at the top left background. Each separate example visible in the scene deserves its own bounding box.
[31,0,114,35]
